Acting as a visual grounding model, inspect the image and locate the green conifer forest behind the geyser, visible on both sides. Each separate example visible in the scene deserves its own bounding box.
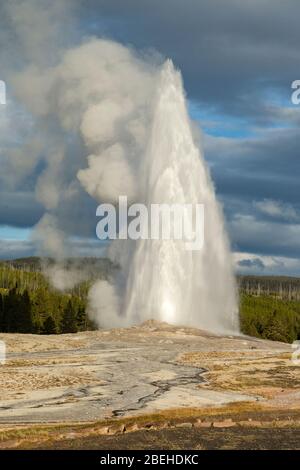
[0,260,300,343]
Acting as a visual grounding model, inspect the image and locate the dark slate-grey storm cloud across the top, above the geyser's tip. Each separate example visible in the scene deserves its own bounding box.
[81,0,300,122]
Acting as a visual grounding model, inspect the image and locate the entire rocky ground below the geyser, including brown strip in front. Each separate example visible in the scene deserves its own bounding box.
[0,321,300,448]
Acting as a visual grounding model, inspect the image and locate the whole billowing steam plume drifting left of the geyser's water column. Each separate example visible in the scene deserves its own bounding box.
[1,0,161,288]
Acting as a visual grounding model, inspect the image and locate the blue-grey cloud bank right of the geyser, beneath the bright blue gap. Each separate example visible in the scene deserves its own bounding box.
[205,129,300,260]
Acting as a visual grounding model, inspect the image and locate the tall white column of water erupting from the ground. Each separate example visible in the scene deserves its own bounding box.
[124,61,238,332]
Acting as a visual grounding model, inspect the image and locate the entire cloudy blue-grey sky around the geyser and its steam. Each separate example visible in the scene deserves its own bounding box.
[0,0,300,275]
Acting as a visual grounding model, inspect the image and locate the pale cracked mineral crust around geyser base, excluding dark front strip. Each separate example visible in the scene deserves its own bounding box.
[0,321,300,424]
